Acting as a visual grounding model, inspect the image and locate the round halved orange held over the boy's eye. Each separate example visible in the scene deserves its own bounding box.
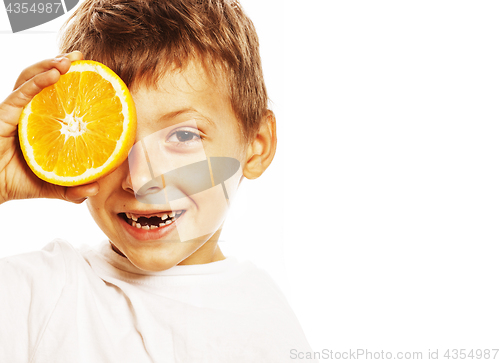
[19,60,137,186]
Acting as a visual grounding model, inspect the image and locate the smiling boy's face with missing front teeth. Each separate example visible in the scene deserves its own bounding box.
[87,62,246,271]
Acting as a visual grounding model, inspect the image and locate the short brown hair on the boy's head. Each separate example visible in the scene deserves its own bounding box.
[59,0,268,142]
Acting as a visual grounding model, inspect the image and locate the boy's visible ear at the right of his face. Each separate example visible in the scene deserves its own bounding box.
[243,110,277,179]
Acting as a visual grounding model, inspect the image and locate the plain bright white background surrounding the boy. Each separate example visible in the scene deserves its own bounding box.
[0,0,500,361]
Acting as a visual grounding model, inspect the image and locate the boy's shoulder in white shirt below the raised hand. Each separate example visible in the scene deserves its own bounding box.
[0,240,86,362]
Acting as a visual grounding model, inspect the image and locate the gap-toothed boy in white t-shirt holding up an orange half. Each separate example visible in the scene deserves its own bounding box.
[0,0,310,363]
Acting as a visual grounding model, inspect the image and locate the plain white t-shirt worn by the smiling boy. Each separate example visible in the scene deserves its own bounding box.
[0,240,311,363]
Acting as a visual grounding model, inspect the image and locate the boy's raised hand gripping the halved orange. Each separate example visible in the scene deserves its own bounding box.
[0,51,99,204]
